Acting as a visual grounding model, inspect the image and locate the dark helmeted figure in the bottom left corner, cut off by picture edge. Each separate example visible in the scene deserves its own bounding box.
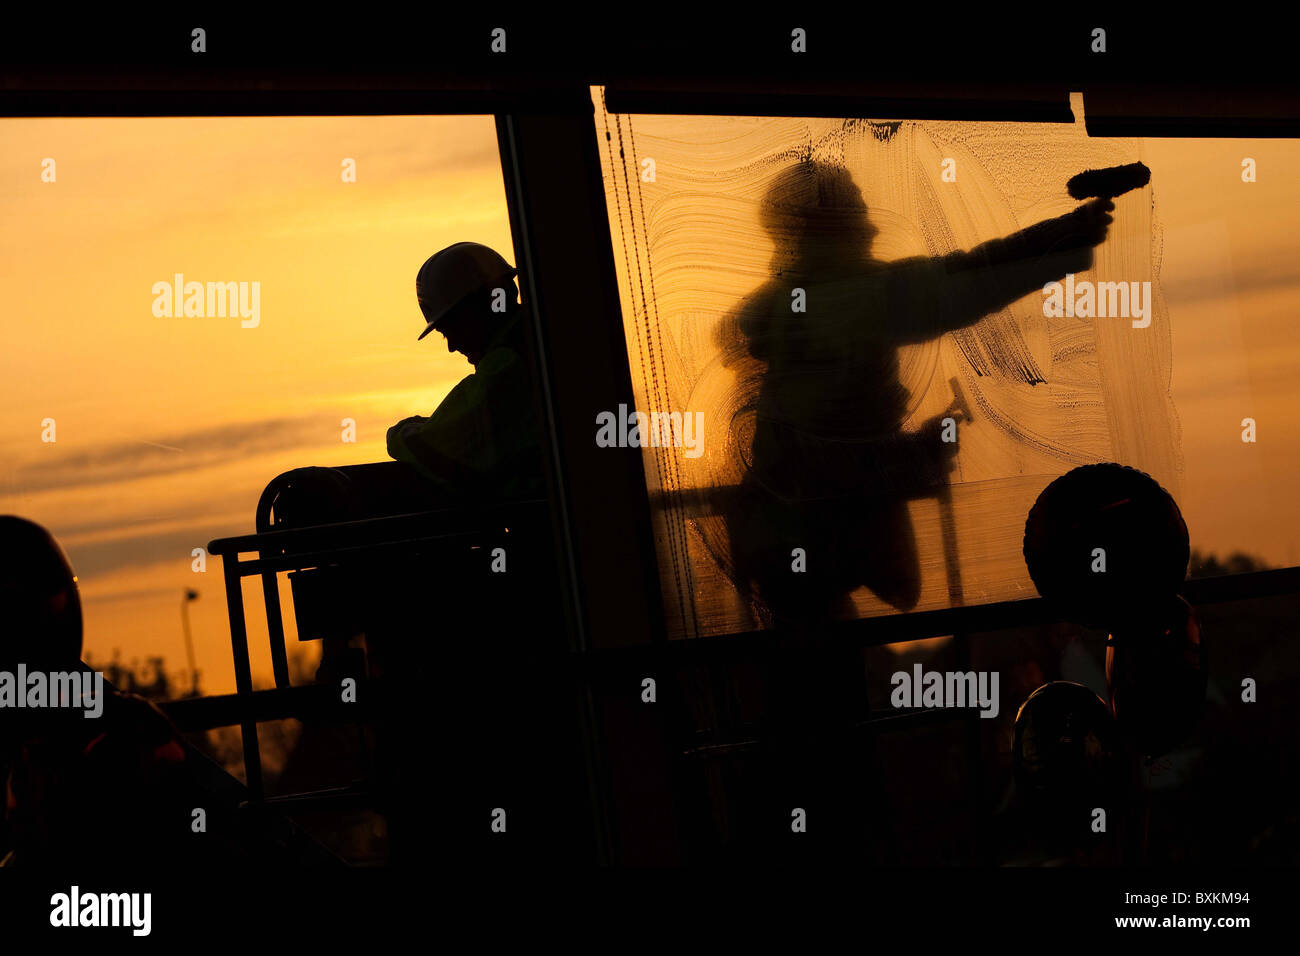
[0,515,335,868]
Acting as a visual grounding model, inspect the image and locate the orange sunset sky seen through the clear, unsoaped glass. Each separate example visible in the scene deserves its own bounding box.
[0,104,1300,693]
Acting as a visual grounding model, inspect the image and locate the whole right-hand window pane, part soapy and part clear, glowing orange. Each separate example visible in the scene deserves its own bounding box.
[593,88,1300,637]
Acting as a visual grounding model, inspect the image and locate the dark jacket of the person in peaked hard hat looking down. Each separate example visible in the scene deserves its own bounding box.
[387,312,545,501]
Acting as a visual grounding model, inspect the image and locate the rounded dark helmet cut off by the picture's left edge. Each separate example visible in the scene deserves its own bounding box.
[0,515,82,667]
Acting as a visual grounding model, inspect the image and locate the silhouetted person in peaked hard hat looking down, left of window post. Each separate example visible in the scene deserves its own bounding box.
[387,242,545,501]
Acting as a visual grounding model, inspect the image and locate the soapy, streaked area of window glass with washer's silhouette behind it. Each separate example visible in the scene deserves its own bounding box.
[594,90,1182,637]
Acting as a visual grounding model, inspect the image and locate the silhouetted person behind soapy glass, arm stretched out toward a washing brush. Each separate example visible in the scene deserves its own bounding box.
[720,161,1114,624]
